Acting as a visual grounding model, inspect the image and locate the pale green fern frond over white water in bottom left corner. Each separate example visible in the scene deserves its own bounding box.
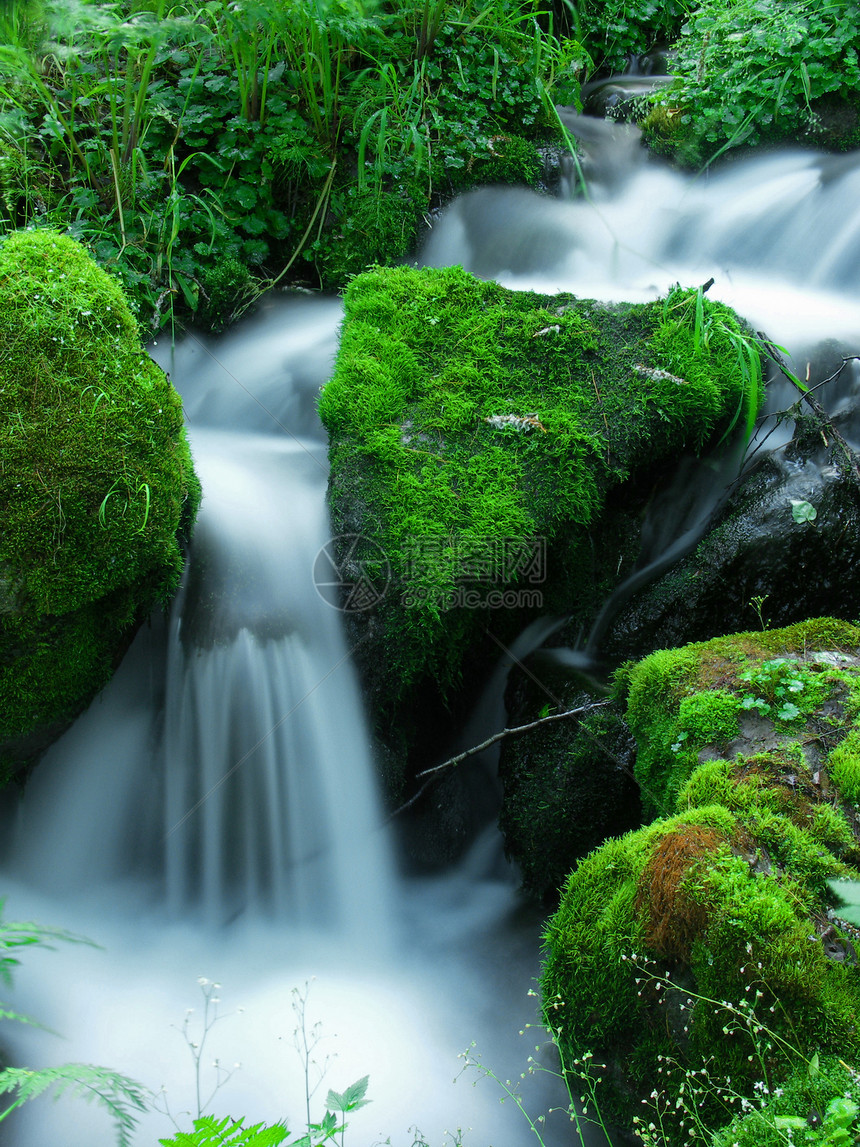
[0,1063,149,1147]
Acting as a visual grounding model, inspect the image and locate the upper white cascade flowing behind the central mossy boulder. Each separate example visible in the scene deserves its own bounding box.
[420,144,860,349]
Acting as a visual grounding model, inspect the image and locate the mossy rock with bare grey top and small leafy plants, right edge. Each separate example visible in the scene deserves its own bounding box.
[617,617,860,817]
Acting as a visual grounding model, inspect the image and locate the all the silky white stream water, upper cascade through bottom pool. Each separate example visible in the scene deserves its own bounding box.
[0,140,860,1147]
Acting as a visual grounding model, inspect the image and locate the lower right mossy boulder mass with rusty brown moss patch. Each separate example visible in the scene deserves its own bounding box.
[542,618,860,1141]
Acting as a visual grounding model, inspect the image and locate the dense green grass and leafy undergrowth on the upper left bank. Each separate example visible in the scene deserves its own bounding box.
[0,0,587,329]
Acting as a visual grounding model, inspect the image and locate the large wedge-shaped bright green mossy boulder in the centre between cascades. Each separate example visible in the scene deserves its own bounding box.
[320,267,760,807]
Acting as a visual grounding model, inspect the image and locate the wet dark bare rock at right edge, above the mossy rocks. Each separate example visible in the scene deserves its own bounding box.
[600,419,860,662]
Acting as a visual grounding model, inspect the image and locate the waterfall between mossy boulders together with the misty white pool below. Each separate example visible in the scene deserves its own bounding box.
[0,298,580,1147]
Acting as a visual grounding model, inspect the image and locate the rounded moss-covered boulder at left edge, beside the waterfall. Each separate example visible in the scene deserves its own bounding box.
[0,231,200,777]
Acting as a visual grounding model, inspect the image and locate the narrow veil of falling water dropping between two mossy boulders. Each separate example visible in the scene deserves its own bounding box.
[164,431,391,937]
